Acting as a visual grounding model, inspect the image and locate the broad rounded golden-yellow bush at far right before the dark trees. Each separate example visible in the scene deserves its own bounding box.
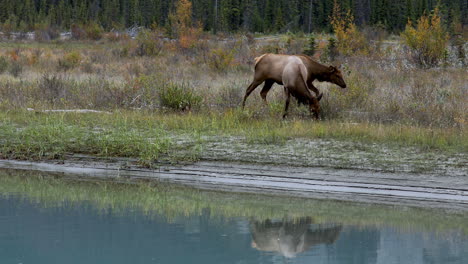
[401,8,449,68]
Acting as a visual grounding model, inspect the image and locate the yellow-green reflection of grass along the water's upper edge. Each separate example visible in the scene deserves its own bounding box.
[0,170,468,234]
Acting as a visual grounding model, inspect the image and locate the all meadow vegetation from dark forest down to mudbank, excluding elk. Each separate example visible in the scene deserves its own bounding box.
[0,1,468,171]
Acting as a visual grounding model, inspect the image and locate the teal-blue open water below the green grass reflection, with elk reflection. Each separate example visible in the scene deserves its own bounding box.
[0,196,468,264]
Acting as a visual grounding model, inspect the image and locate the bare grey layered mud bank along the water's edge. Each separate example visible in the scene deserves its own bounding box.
[0,155,468,211]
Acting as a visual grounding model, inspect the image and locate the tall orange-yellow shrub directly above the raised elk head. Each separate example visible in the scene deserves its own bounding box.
[330,0,369,56]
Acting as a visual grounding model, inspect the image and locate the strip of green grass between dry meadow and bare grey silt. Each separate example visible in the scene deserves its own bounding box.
[0,110,468,164]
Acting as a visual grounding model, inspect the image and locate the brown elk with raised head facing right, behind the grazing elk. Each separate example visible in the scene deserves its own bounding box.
[242,53,346,116]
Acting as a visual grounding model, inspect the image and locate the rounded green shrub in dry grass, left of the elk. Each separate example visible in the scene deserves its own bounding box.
[159,83,202,111]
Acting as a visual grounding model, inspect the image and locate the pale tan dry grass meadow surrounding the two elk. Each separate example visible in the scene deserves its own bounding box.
[0,35,468,129]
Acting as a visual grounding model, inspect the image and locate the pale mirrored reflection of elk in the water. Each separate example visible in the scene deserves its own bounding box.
[250,217,341,258]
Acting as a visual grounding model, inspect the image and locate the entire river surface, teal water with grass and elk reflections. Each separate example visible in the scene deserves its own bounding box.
[0,171,468,264]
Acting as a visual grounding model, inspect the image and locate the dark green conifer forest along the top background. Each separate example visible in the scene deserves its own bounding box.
[0,0,468,33]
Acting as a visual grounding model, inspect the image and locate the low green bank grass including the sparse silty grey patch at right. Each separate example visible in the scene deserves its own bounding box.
[0,110,468,172]
